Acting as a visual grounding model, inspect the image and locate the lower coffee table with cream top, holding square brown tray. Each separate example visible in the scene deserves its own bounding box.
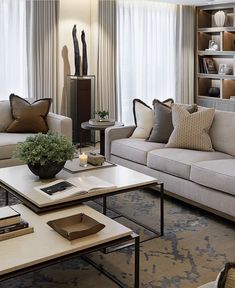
[0,204,139,288]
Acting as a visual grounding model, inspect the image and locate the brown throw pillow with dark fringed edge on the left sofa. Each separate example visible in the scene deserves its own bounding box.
[6,94,52,133]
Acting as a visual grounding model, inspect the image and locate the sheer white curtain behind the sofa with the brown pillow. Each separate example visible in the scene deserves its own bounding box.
[0,0,28,100]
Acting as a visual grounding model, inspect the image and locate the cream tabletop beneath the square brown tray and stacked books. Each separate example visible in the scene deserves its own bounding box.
[0,204,132,275]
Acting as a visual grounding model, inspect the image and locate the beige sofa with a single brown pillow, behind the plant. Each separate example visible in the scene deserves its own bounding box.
[0,101,72,167]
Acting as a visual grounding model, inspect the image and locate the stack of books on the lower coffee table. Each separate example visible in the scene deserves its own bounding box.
[0,206,33,241]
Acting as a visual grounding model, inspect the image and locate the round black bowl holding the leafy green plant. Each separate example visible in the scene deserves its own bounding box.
[28,162,65,179]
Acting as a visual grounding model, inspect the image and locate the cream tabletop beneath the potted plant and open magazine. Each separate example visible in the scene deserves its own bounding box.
[0,165,157,208]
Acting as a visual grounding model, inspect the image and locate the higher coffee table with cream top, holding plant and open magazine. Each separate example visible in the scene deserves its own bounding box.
[0,165,164,235]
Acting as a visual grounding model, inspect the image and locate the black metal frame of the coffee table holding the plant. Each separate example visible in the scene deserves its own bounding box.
[0,181,164,236]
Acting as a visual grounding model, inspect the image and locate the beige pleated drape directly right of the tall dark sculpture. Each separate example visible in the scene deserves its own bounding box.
[96,0,117,119]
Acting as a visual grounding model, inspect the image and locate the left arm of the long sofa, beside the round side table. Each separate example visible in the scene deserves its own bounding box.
[105,125,136,160]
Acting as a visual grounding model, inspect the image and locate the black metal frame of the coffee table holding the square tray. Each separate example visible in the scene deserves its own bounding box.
[0,233,140,288]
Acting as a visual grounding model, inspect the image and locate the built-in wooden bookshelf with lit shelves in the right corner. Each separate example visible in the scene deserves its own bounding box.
[195,3,235,111]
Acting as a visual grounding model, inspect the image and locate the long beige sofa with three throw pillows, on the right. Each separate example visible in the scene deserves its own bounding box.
[105,107,235,221]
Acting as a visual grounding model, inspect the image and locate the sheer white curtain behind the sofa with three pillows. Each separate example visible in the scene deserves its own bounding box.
[117,0,177,124]
